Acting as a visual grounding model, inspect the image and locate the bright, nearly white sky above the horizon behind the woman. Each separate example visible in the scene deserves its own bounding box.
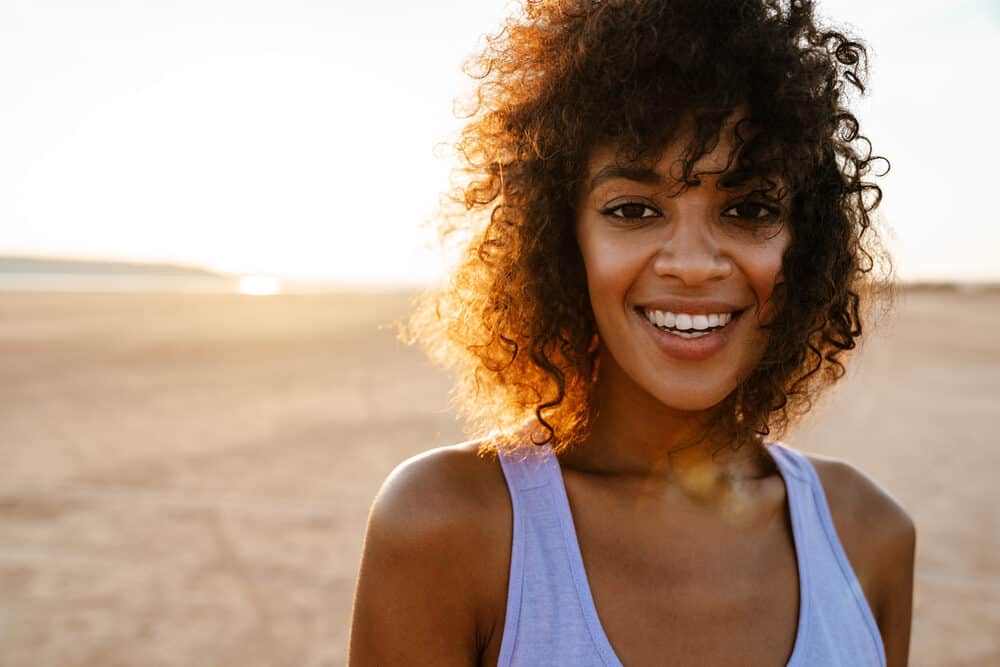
[0,0,1000,285]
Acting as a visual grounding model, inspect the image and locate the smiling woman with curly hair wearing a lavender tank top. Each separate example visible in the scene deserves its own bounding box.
[350,0,915,667]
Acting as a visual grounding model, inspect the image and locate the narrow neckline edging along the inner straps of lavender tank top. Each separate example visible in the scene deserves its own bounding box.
[528,443,811,667]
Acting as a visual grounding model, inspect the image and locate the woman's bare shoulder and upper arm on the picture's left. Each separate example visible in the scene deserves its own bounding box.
[349,443,512,665]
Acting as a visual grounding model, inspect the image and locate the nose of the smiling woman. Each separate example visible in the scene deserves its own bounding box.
[653,216,733,285]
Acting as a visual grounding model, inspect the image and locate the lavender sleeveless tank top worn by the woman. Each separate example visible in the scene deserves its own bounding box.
[498,443,885,667]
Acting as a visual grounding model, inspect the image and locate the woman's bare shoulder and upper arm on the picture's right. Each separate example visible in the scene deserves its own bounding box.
[810,457,916,667]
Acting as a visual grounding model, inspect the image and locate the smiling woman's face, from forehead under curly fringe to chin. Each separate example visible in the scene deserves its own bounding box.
[576,124,790,411]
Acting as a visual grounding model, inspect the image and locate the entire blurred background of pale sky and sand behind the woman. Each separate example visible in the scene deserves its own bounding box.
[0,0,1000,666]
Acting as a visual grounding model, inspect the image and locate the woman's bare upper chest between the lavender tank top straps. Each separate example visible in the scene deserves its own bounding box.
[566,479,799,667]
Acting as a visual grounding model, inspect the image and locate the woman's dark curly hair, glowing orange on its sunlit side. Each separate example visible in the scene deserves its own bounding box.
[409,0,891,451]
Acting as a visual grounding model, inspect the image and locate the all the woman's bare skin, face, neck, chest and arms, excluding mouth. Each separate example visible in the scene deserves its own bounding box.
[349,126,915,666]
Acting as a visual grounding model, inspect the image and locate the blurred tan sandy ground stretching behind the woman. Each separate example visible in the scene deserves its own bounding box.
[0,291,1000,667]
